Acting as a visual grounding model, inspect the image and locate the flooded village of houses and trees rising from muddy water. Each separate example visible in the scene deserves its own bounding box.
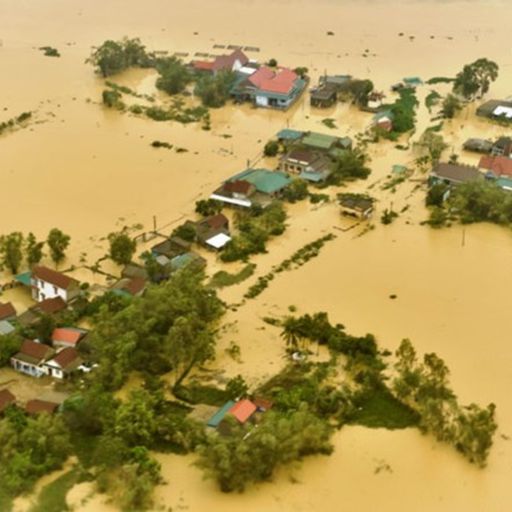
[0,39,512,510]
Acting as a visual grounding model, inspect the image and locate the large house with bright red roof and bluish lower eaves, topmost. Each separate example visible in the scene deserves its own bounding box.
[231,66,307,110]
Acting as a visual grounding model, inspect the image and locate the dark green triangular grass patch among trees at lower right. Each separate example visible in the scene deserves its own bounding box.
[348,386,420,430]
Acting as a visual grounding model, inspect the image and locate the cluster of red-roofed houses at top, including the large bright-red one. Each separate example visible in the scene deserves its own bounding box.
[191,49,308,110]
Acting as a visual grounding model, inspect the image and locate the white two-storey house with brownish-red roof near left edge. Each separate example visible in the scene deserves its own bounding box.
[30,265,80,302]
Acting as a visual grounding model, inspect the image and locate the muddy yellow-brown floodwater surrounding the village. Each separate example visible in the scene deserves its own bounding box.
[0,0,512,512]
